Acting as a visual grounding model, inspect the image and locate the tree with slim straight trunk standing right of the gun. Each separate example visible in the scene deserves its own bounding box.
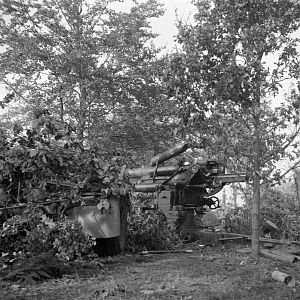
[167,0,300,258]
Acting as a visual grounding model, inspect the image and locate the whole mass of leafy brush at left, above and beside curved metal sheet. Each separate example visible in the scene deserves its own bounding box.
[0,115,130,260]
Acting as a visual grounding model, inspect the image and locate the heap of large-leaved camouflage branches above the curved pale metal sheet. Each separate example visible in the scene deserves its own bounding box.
[0,112,130,206]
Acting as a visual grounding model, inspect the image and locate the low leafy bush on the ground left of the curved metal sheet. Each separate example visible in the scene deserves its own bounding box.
[0,213,93,260]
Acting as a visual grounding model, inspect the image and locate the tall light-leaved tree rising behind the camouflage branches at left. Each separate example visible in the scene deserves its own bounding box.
[0,0,176,158]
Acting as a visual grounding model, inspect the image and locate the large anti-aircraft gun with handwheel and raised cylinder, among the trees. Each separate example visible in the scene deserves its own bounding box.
[128,143,246,234]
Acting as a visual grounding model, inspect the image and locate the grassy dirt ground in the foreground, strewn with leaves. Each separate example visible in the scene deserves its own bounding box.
[0,243,300,300]
